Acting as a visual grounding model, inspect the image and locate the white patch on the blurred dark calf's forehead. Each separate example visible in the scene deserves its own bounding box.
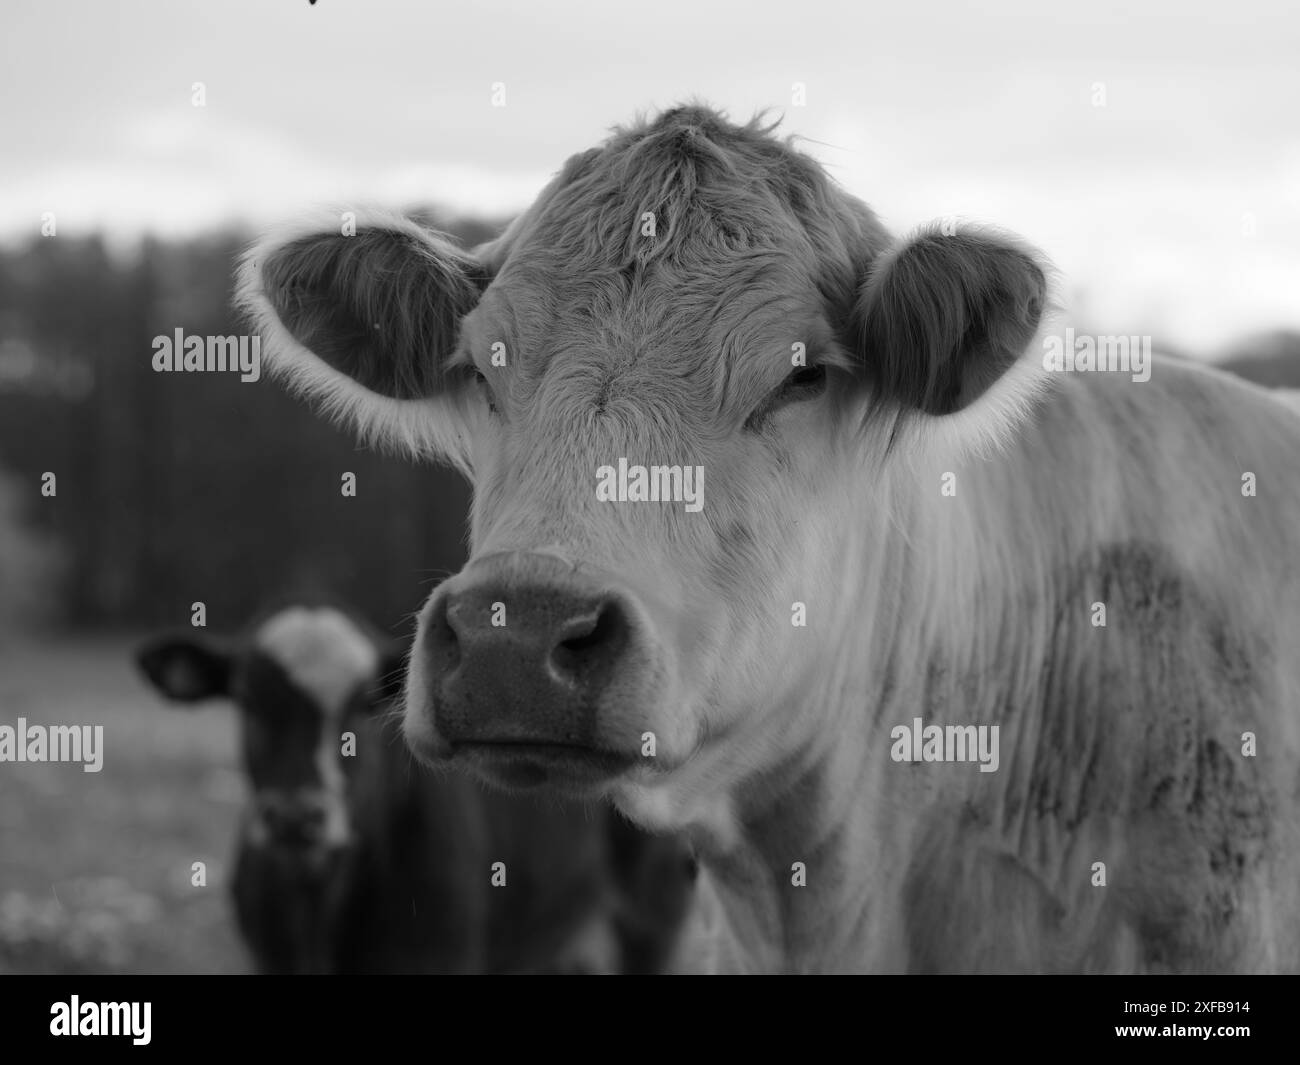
[254,607,380,714]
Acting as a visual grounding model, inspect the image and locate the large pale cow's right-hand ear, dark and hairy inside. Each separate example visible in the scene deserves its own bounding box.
[858,226,1048,415]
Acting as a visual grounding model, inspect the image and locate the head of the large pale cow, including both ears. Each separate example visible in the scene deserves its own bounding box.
[241,109,1044,827]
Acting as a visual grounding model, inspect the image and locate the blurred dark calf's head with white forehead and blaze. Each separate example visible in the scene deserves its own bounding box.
[137,607,402,863]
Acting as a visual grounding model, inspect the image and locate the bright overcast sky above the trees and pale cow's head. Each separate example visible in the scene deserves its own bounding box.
[0,0,1300,351]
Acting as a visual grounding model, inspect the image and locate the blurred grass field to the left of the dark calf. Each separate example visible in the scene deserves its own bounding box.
[0,638,248,973]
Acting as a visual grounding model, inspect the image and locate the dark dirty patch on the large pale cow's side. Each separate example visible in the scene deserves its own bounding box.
[899,542,1275,971]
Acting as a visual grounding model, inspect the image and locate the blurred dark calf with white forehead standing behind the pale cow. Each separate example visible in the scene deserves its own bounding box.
[138,603,680,974]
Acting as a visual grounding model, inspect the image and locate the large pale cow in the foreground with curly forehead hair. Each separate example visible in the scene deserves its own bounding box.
[237,104,1300,973]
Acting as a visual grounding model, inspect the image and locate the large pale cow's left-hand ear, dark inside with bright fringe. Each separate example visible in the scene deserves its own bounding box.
[235,212,489,451]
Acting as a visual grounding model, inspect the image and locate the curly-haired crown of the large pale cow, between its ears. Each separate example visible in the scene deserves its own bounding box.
[493,107,889,338]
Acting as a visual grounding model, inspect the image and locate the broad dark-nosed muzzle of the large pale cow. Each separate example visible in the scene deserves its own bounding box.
[406,553,658,791]
